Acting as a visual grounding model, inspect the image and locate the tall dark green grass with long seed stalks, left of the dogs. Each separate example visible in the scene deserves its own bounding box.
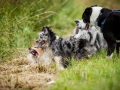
[0,0,71,60]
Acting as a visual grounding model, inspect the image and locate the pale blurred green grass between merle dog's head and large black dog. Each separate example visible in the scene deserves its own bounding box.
[52,0,83,36]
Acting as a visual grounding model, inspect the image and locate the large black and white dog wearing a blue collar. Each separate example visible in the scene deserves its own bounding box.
[82,5,120,58]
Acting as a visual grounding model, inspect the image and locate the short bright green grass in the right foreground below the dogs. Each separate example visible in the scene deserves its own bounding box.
[50,52,120,90]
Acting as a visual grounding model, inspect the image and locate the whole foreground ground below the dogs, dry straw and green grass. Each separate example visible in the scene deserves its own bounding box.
[0,51,120,90]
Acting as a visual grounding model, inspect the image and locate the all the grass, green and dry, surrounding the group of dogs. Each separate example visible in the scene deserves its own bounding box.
[0,0,120,90]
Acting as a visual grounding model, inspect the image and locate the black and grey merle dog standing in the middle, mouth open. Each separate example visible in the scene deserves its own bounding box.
[36,26,88,70]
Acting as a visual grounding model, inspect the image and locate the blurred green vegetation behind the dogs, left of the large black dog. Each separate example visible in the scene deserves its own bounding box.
[0,0,86,61]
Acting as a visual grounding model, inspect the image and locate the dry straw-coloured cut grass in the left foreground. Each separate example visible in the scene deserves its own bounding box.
[0,55,56,90]
